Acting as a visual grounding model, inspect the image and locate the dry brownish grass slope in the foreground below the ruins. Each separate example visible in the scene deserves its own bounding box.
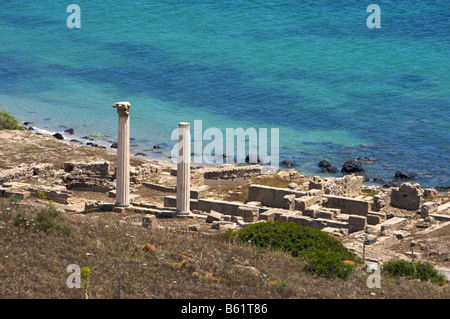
[0,199,450,299]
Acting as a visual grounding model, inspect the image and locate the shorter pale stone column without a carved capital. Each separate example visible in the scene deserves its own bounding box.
[177,122,191,214]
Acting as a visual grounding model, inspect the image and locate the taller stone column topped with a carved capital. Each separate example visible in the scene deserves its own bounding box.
[113,102,131,207]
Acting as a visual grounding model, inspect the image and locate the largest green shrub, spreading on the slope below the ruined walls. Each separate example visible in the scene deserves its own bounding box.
[227,221,362,279]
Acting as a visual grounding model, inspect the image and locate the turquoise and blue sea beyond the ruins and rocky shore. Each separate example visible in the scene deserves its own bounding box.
[0,0,450,187]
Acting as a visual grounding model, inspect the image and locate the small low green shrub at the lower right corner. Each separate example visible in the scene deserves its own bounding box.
[383,259,447,286]
